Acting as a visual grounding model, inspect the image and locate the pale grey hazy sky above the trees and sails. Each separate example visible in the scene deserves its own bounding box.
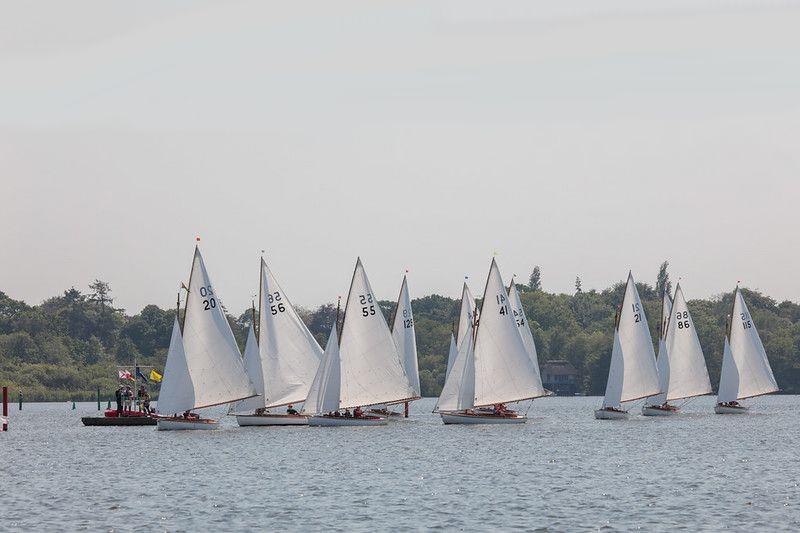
[0,0,800,312]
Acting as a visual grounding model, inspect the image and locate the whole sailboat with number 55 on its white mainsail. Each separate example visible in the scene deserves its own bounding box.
[303,258,419,426]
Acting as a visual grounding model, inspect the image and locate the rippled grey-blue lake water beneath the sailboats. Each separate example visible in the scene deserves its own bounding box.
[0,396,800,531]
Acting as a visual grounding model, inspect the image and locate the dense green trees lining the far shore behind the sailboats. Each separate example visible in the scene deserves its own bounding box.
[0,263,800,401]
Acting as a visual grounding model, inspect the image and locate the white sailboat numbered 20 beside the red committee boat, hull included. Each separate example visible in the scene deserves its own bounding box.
[158,246,258,430]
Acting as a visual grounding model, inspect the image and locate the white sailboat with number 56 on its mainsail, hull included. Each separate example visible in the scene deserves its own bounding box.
[232,257,322,426]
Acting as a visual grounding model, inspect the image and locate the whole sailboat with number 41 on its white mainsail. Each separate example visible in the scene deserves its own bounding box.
[436,259,547,424]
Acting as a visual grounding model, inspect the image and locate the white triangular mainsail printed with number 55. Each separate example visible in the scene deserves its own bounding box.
[339,258,419,409]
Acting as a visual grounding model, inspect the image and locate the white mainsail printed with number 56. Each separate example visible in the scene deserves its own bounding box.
[258,259,322,407]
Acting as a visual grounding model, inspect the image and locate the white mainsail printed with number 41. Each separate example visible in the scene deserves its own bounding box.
[475,259,546,406]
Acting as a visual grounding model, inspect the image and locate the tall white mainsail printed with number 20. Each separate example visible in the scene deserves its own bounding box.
[177,248,257,409]
